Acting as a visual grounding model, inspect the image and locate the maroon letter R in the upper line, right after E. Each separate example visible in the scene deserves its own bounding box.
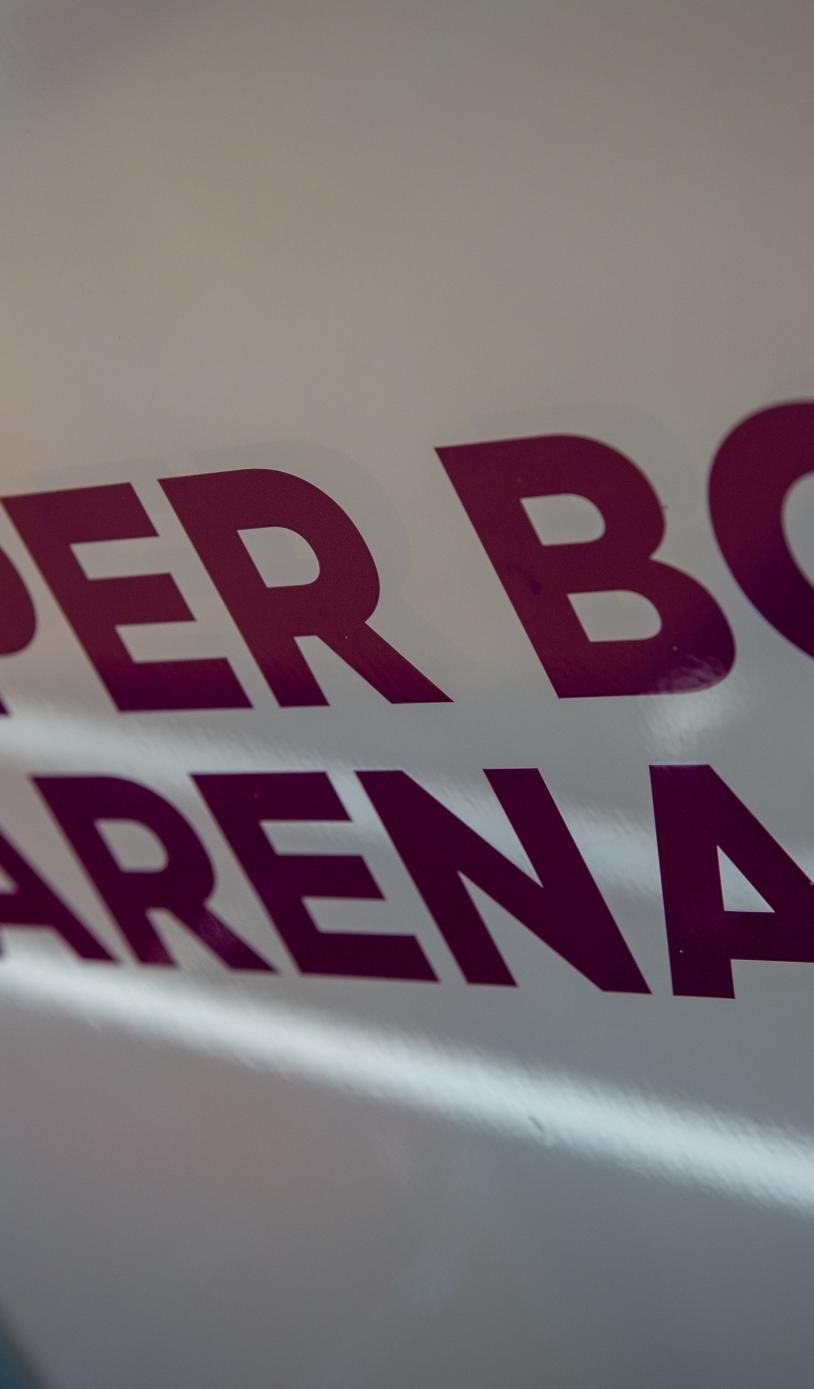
[161,468,447,706]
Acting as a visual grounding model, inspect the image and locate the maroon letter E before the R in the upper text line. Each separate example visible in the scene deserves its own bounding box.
[3,482,250,711]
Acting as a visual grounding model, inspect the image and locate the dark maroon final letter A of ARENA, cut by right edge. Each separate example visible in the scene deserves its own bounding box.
[650,767,814,999]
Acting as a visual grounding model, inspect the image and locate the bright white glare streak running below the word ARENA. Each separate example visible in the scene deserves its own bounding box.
[0,960,814,1214]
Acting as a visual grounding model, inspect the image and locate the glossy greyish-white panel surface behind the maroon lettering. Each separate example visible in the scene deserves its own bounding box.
[0,0,814,1389]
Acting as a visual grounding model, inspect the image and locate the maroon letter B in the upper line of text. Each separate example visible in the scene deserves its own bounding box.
[438,435,735,699]
